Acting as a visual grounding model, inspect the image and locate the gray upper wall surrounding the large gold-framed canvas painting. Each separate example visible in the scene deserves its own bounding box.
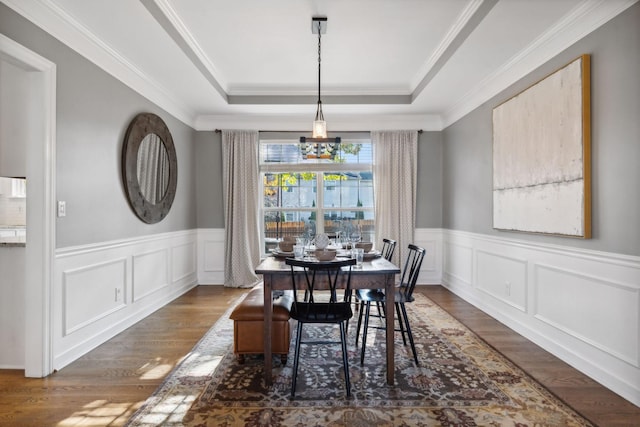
[443,4,640,256]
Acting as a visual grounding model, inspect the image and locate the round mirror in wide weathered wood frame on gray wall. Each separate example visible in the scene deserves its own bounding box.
[122,113,178,224]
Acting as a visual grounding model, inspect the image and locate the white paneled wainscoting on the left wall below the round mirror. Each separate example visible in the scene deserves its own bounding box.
[52,230,198,369]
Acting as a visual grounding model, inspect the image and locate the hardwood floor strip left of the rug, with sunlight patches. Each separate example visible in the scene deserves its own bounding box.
[0,286,247,427]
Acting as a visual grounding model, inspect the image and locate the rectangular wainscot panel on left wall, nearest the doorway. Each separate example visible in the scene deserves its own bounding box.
[63,258,126,336]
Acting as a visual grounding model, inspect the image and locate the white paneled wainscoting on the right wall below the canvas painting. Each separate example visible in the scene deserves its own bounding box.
[440,230,640,406]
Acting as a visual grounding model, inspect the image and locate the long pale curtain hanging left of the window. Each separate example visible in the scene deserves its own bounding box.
[222,130,260,288]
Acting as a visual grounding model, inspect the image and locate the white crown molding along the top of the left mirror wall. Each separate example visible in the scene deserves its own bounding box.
[2,0,196,127]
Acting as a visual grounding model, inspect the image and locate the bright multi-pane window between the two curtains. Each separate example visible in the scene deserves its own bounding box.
[260,138,374,252]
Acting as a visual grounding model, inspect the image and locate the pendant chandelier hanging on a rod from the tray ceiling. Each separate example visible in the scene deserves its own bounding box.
[300,16,340,159]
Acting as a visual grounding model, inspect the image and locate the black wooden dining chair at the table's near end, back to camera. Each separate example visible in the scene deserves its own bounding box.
[285,258,356,398]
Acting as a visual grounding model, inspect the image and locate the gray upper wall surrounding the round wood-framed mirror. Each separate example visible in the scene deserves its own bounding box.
[0,4,196,248]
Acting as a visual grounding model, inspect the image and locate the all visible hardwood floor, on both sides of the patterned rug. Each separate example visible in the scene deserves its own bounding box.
[0,286,640,427]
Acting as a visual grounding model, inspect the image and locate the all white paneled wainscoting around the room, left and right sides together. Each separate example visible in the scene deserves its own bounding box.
[52,229,640,406]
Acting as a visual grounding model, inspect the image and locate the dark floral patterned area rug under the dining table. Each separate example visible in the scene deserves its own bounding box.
[127,295,592,427]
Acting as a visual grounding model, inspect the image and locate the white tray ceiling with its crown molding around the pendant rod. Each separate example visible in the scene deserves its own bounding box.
[2,0,637,131]
